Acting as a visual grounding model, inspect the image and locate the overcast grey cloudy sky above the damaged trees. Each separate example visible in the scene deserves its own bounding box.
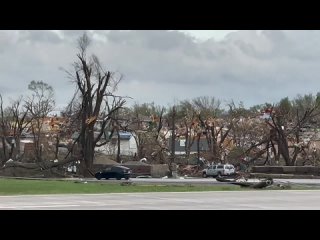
[0,30,320,111]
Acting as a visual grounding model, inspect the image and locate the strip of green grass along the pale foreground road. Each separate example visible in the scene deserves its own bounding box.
[0,179,242,195]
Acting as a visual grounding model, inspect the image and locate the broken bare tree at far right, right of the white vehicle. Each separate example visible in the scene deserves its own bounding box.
[241,95,320,166]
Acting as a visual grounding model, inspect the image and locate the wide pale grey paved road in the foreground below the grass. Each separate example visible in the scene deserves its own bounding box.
[0,190,320,210]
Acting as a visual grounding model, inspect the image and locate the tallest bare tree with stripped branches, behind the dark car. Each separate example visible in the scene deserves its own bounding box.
[68,34,125,176]
